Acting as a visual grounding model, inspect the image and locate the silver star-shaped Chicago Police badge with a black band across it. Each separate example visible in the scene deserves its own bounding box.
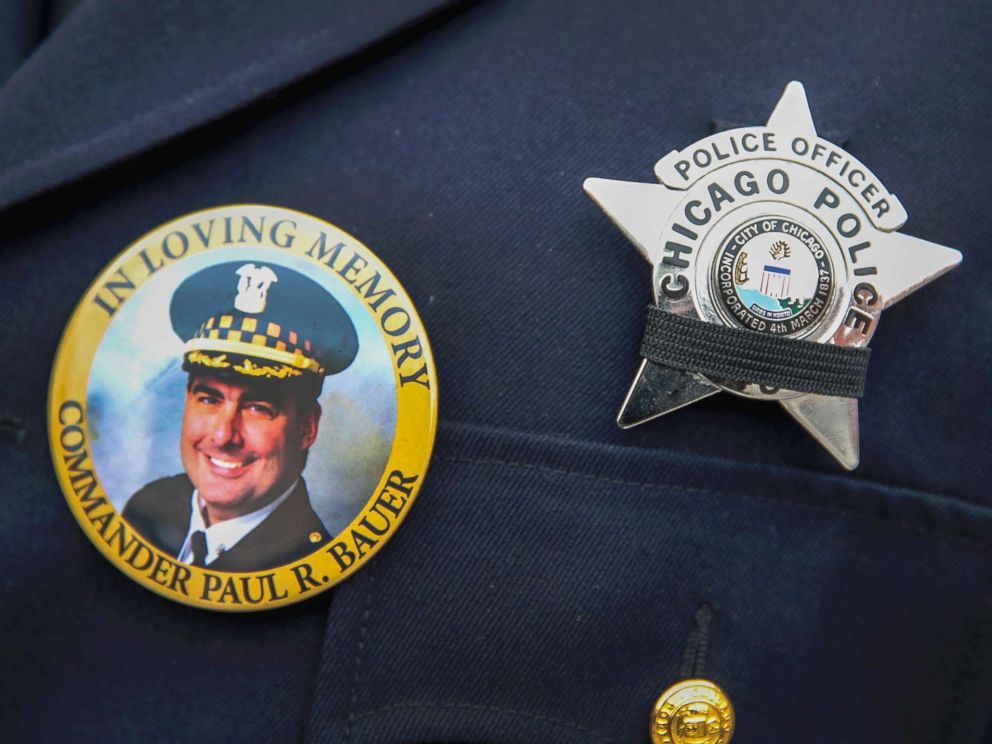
[584,82,961,470]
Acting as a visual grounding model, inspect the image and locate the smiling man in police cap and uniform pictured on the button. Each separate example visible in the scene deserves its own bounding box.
[123,262,358,571]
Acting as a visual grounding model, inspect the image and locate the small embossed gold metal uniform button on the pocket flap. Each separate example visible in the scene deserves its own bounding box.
[651,679,734,744]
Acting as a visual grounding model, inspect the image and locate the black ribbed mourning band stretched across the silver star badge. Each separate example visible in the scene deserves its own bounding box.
[641,305,871,398]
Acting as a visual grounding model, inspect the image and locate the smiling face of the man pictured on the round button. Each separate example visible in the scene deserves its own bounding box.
[180,375,320,523]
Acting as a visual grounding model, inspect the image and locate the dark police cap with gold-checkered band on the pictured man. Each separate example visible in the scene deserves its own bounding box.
[169,262,358,383]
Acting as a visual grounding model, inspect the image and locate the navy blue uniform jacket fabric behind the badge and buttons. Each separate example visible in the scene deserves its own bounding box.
[0,0,992,744]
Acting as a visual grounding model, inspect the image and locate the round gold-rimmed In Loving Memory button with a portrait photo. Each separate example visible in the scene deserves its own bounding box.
[48,205,437,610]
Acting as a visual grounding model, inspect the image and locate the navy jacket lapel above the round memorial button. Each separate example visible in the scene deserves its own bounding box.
[0,0,474,215]
